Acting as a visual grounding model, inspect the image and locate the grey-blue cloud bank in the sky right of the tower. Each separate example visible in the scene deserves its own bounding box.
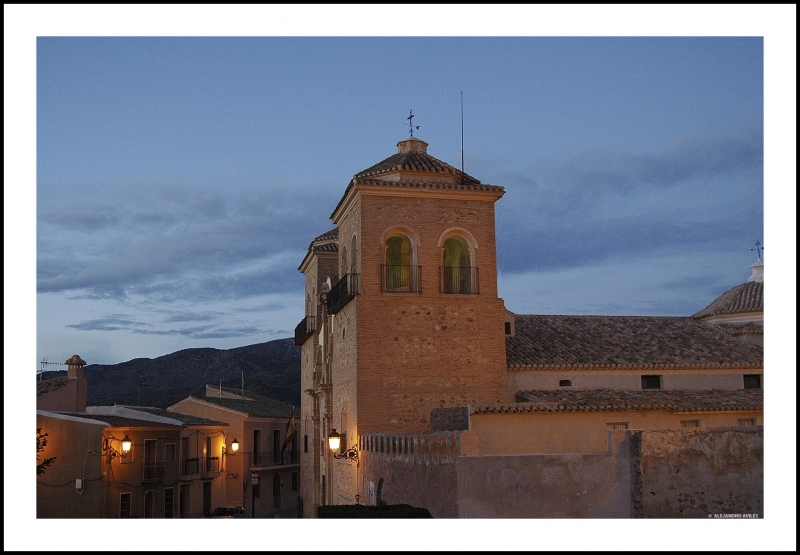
[497,133,763,273]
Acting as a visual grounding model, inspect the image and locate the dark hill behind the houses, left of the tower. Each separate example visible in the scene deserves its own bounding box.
[42,338,300,408]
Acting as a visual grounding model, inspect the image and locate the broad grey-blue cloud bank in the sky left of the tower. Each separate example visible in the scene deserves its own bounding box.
[37,177,330,302]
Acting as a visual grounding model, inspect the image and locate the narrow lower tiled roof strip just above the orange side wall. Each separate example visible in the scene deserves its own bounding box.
[471,389,764,414]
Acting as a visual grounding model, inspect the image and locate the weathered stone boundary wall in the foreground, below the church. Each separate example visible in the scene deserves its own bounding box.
[360,426,763,519]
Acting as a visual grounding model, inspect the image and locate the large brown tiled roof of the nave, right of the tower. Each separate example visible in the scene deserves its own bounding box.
[506,315,764,369]
